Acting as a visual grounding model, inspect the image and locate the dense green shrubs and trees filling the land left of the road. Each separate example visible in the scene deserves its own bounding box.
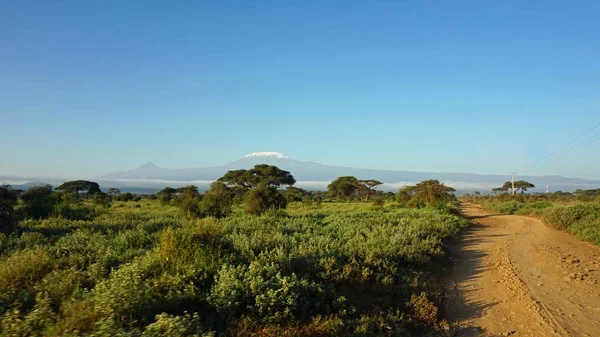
[0,171,467,336]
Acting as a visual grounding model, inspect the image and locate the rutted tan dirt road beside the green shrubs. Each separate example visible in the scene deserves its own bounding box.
[446,204,600,337]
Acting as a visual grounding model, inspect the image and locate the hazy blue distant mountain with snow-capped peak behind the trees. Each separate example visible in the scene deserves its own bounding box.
[100,152,600,191]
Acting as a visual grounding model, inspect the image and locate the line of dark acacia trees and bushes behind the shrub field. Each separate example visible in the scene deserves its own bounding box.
[0,164,456,232]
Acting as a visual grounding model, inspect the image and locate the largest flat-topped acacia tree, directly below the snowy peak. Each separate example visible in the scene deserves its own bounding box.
[218,164,296,190]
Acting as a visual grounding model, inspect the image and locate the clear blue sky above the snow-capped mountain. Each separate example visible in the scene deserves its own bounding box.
[0,0,600,179]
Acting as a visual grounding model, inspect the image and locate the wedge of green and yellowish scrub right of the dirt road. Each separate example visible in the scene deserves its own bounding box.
[463,190,600,245]
